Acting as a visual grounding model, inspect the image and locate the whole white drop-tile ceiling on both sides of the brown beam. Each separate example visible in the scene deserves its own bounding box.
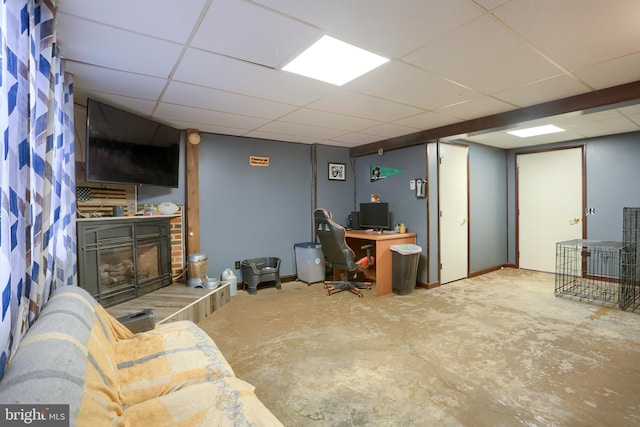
[56,0,640,148]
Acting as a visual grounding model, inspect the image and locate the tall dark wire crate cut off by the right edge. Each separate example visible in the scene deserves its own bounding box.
[620,208,640,310]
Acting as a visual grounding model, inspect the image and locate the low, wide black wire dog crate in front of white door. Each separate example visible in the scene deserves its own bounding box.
[555,239,626,306]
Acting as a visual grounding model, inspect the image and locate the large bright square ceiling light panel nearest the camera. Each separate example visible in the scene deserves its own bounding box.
[282,36,389,86]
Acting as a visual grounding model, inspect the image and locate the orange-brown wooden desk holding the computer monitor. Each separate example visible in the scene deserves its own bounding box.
[345,230,416,295]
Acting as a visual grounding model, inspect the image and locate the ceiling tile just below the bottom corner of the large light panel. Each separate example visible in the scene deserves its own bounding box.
[308,90,424,122]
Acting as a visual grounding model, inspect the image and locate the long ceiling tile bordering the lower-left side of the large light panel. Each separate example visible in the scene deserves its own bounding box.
[174,49,336,106]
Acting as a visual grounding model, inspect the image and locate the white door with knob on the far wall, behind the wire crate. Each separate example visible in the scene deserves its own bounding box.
[516,148,583,273]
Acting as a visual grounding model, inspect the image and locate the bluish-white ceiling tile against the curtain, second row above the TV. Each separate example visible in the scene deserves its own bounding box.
[65,61,166,101]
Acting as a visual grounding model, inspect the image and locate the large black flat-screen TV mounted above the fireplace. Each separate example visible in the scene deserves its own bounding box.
[85,99,180,187]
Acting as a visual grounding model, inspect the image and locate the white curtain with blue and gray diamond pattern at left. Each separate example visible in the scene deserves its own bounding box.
[0,0,77,378]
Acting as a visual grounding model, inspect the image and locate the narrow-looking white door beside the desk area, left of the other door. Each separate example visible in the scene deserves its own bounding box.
[438,144,469,284]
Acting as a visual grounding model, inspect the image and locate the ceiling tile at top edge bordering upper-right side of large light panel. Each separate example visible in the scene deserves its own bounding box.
[255,0,482,58]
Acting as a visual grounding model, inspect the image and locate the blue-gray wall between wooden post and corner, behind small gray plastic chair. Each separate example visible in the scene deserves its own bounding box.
[199,134,312,280]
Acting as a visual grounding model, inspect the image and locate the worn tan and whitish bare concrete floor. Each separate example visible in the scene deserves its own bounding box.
[200,269,640,426]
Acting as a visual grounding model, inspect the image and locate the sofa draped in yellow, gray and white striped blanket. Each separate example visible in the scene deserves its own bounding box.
[0,286,282,427]
